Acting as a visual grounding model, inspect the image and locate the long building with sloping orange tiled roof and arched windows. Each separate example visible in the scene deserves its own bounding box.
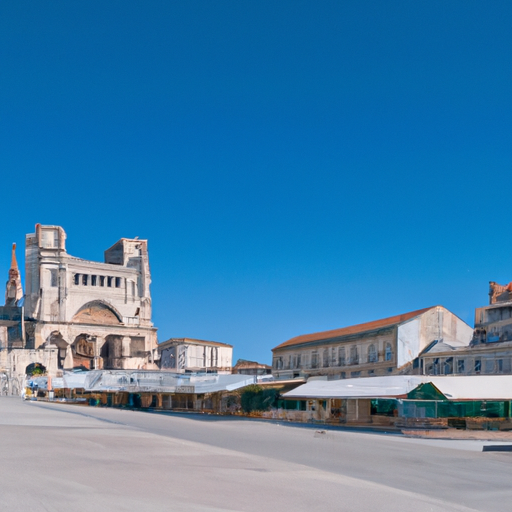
[272,306,473,379]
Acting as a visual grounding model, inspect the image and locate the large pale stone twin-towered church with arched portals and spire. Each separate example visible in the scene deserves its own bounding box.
[0,224,156,392]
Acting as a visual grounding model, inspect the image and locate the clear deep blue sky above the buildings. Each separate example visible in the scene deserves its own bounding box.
[0,4,512,362]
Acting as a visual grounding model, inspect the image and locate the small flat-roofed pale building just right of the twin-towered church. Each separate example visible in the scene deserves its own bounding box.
[158,338,233,373]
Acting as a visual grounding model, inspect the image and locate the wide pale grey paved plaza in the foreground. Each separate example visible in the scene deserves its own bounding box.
[0,397,512,512]
